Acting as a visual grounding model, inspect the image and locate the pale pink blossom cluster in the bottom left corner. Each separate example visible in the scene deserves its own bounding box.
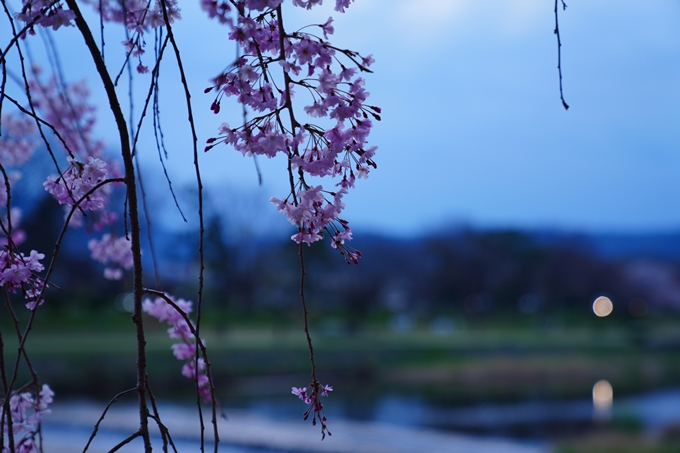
[0,384,54,453]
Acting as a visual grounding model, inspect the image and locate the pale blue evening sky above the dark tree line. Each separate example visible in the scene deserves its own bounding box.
[5,0,680,235]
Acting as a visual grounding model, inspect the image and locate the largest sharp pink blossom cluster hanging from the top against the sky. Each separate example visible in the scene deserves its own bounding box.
[201,0,380,263]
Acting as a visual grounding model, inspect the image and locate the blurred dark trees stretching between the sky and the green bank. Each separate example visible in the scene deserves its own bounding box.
[14,189,680,334]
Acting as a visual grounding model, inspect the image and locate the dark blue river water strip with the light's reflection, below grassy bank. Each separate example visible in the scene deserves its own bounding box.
[226,388,680,440]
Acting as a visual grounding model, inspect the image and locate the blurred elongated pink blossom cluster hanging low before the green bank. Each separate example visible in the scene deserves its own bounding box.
[142,296,211,402]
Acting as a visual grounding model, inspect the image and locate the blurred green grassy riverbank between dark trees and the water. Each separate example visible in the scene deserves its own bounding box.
[3,320,680,404]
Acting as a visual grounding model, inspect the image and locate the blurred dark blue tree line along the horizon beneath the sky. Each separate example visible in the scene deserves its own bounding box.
[17,192,680,325]
